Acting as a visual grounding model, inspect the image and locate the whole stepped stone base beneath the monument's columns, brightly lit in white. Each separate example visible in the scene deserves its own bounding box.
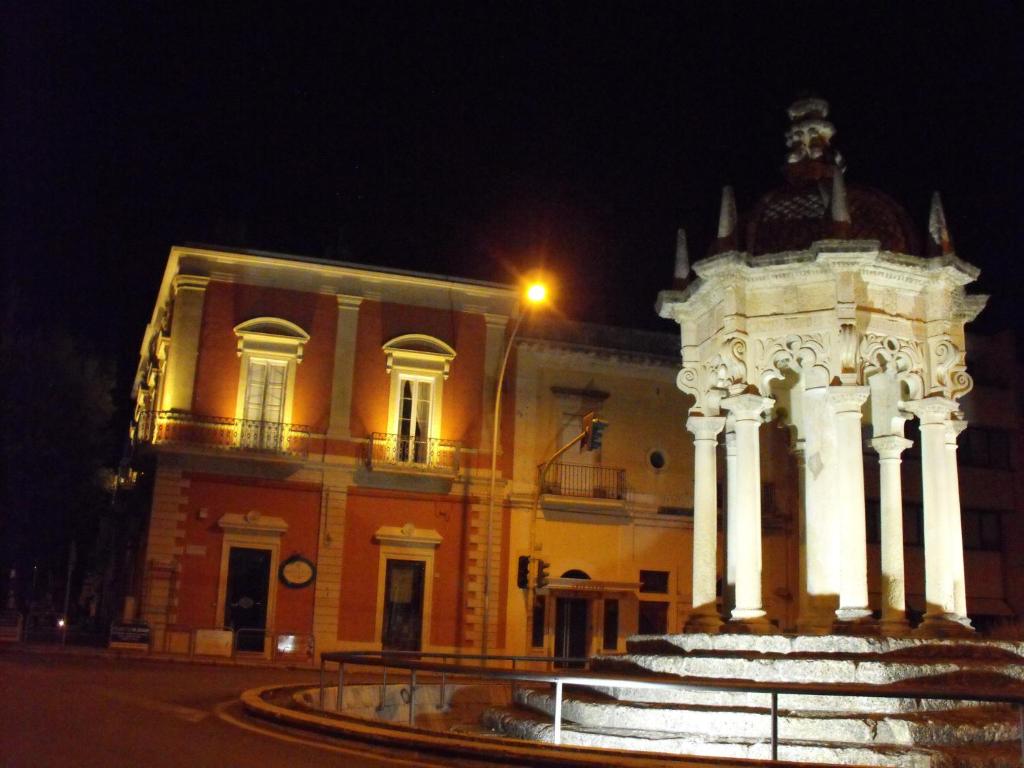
[483,634,1024,768]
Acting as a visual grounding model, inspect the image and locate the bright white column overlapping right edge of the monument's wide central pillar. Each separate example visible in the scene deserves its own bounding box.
[828,386,871,622]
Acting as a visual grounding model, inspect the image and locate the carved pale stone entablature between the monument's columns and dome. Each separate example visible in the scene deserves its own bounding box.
[657,242,986,416]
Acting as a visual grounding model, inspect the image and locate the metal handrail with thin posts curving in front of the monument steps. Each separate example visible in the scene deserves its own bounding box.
[319,651,1024,762]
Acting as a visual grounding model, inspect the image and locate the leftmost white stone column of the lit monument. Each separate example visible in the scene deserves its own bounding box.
[683,416,725,632]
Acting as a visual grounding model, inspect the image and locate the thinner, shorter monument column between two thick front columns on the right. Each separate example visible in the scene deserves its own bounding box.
[871,435,913,635]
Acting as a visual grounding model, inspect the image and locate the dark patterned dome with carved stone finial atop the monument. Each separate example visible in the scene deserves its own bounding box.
[737,98,921,254]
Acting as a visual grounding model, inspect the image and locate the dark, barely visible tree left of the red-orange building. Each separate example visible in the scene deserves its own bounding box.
[0,330,114,610]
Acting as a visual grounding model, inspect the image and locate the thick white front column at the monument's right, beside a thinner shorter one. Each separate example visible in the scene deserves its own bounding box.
[904,397,968,637]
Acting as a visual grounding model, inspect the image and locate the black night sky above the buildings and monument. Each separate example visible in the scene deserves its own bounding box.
[2,2,1024,409]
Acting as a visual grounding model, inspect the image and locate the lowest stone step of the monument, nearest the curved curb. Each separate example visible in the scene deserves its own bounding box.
[482,709,950,768]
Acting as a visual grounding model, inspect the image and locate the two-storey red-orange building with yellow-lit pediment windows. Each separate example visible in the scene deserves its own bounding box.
[134,248,517,654]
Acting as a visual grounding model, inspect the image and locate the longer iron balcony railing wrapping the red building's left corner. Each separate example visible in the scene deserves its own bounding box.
[135,411,310,458]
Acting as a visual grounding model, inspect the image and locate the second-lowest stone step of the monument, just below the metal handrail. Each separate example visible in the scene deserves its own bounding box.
[514,688,1020,745]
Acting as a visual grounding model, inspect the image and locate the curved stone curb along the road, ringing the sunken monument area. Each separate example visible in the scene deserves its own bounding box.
[241,685,815,768]
